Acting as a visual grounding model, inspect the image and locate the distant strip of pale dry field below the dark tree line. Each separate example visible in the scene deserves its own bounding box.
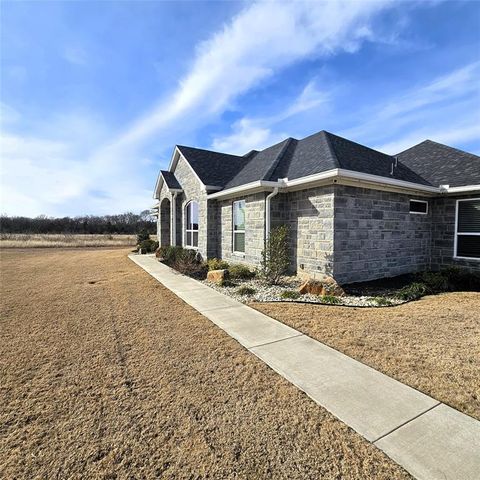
[0,233,139,248]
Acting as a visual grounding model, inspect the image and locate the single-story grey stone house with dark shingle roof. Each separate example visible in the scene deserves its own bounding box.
[154,131,480,283]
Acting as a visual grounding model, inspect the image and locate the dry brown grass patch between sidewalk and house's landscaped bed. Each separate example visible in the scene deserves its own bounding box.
[251,292,480,420]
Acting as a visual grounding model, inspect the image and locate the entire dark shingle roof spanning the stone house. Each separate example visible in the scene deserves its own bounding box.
[174,130,480,189]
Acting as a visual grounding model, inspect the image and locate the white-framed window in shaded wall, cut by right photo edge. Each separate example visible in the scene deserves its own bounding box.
[453,198,480,259]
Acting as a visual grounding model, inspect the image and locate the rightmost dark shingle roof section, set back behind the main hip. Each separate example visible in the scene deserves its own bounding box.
[397,140,480,187]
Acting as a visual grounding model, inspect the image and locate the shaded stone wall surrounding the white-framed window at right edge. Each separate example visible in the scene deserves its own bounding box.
[431,194,480,272]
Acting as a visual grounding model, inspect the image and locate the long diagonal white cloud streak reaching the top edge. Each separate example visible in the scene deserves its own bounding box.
[108,0,390,147]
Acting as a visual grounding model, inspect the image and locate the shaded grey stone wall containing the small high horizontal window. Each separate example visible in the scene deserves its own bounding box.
[334,185,432,283]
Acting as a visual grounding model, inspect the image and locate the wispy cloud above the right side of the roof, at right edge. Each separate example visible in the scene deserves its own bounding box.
[340,62,480,154]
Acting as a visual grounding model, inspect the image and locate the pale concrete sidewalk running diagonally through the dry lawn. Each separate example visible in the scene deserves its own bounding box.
[129,254,480,480]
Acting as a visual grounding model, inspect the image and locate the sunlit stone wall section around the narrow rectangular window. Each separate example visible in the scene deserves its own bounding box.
[218,192,267,266]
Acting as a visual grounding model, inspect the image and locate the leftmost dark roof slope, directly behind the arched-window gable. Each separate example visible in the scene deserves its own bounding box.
[177,145,249,187]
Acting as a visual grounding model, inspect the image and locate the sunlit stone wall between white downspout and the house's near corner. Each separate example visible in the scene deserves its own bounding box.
[271,186,334,278]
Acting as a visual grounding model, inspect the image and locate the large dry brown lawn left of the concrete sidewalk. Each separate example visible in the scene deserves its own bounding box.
[0,249,412,479]
